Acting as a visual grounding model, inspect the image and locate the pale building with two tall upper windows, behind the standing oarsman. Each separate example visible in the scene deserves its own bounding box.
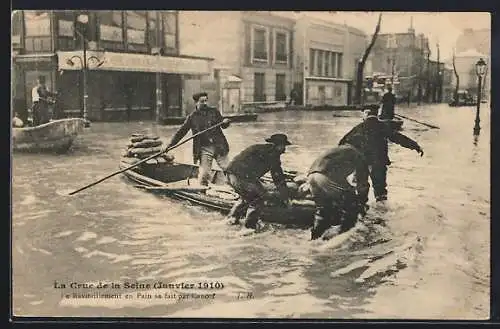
[179,11,295,113]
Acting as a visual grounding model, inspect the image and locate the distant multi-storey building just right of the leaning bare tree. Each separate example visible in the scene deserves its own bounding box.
[370,27,431,101]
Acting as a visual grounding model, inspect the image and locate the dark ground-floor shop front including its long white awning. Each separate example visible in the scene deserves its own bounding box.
[57,51,211,121]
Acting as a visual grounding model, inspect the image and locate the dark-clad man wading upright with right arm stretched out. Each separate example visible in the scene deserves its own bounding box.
[339,108,424,201]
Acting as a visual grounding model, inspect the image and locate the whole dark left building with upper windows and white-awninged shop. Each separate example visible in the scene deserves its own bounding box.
[12,10,212,120]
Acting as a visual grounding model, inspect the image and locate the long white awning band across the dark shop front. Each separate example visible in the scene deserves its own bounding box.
[57,50,213,75]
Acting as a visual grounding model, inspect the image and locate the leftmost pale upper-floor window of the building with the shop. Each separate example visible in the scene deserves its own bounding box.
[24,10,52,52]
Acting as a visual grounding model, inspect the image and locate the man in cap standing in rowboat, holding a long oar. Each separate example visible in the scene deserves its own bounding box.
[166,92,230,186]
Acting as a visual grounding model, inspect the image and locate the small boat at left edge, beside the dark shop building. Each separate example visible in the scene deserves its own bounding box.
[12,118,86,153]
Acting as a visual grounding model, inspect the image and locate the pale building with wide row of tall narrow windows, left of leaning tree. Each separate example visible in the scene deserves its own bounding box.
[293,15,366,106]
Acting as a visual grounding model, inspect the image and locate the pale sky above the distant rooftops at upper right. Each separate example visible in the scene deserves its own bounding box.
[272,11,491,60]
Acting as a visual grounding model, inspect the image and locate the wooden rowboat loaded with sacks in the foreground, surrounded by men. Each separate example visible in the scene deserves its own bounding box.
[119,157,315,228]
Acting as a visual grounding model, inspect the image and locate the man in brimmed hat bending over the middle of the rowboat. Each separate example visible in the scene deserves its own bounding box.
[226,134,291,228]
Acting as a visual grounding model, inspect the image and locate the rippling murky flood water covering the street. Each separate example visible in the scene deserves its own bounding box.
[12,104,490,319]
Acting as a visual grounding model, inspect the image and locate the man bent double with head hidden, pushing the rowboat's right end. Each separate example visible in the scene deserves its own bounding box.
[297,144,370,240]
